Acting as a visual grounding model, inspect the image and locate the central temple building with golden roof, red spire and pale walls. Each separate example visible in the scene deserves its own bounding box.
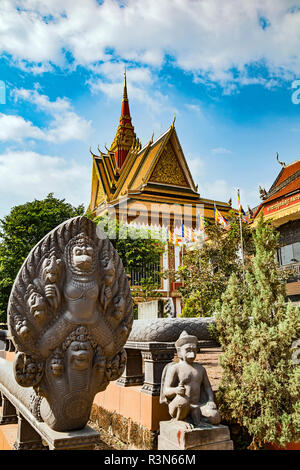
[89,73,231,314]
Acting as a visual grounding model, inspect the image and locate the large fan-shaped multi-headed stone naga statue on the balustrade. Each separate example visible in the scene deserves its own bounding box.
[8,217,133,431]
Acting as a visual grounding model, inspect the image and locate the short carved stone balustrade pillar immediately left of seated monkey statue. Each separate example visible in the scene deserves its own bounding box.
[141,343,175,396]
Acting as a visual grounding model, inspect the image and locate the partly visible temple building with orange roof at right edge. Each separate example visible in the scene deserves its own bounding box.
[253,154,300,303]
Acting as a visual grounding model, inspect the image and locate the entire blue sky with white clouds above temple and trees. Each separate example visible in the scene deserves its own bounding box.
[0,0,300,217]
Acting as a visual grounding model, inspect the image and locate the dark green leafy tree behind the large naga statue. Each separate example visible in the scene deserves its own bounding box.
[0,193,84,322]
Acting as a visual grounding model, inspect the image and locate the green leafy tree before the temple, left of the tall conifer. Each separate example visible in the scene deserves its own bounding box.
[177,211,254,317]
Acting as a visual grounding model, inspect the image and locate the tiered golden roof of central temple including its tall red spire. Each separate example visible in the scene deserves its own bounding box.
[89,74,231,225]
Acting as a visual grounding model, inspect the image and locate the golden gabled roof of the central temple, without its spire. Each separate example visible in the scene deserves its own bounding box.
[90,119,199,210]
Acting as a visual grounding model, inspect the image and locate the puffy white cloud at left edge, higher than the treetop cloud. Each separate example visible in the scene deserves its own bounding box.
[0,88,91,142]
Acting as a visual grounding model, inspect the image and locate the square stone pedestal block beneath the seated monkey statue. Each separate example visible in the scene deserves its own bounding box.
[157,421,233,450]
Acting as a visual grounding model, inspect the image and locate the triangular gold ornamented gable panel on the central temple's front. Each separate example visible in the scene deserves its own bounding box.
[150,145,189,187]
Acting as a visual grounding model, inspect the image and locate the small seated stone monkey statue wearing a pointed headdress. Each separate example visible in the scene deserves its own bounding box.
[160,331,221,426]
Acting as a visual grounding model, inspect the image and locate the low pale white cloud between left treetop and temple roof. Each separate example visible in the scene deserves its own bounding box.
[0,150,91,218]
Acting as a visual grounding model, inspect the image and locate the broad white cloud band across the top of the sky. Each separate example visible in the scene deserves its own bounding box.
[0,0,300,92]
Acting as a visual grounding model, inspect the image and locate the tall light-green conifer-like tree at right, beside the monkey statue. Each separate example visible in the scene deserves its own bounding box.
[216,218,300,449]
